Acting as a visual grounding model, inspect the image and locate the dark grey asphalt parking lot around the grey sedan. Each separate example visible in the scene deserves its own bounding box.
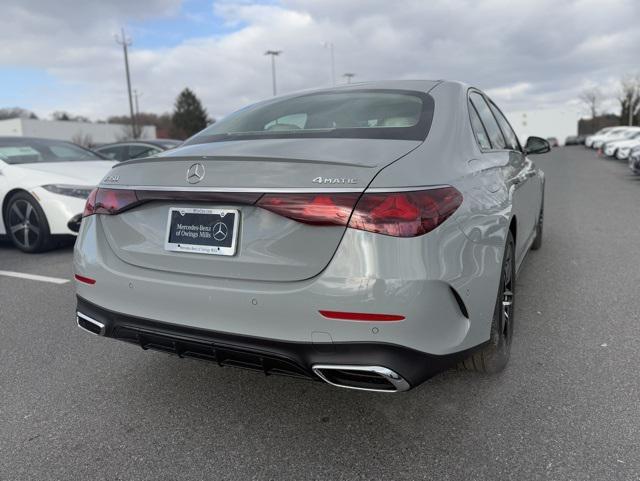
[0,147,640,481]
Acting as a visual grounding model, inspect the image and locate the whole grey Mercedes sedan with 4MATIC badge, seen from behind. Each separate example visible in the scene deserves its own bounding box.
[75,81,549,392]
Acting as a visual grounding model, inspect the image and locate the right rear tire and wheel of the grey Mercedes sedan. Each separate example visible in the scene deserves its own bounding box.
[460,232,516,374]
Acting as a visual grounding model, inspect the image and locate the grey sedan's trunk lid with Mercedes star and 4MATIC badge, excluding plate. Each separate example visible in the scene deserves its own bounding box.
[100,139,420,281]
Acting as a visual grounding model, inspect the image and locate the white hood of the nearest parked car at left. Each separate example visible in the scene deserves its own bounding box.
[16,160,117,186]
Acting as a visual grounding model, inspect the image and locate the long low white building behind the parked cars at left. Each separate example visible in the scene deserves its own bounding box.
[0,119,156,145]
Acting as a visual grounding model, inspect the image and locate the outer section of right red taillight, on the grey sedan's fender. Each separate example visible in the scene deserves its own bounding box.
[349,186,462,237]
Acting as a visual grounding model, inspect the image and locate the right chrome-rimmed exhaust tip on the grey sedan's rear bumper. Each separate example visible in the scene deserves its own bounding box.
[311,364,411,392]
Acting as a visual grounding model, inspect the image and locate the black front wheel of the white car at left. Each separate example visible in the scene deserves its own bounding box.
[4,192,53,254]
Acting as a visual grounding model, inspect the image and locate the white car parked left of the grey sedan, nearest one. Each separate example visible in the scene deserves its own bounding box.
[0,137,116,252]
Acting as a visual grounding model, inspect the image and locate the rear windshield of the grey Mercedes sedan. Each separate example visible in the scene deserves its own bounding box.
[185,89,433,145]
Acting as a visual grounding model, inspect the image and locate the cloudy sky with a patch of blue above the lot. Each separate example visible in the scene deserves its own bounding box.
[0,0,640,135]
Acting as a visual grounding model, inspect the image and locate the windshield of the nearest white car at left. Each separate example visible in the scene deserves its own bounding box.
[0,138,103,164]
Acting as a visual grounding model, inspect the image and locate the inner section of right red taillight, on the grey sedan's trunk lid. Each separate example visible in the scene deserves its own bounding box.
[257,193,360,226]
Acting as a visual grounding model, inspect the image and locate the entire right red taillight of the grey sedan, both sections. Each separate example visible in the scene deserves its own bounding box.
[257,186,462,237]
